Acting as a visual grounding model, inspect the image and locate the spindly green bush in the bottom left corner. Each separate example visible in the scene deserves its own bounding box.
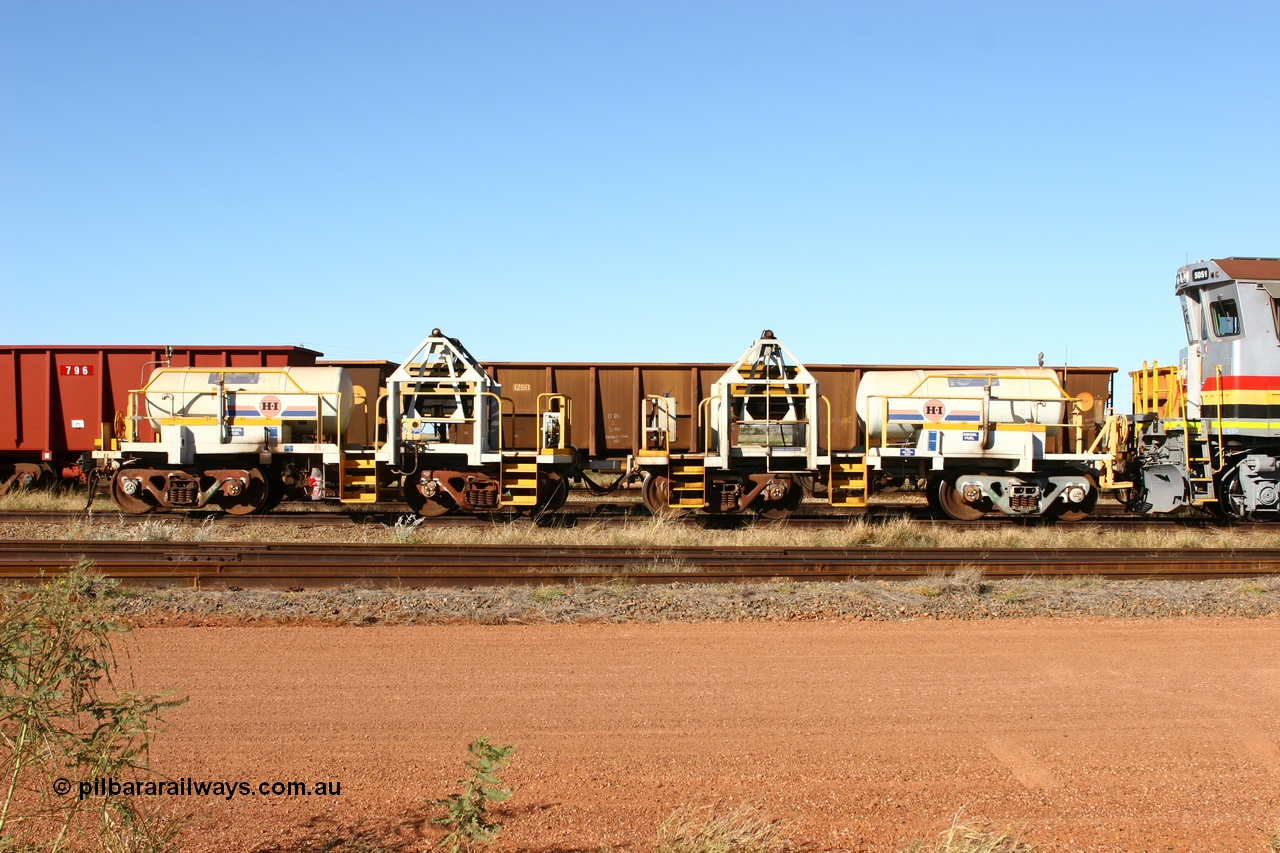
[0,564,184,853]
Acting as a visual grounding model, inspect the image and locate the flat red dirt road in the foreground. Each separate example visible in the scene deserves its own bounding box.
[134,620,1280,853]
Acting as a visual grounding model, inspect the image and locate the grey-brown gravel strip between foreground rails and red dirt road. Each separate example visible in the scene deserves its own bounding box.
[112,573,1280,626]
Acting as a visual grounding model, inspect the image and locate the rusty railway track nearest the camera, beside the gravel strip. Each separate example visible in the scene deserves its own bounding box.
[0,540,1280,589]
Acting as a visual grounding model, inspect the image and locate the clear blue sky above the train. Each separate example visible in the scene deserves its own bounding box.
[0,0,1280,384]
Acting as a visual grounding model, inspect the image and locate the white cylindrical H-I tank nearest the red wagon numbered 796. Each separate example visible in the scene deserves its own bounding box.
[145,368,355,443]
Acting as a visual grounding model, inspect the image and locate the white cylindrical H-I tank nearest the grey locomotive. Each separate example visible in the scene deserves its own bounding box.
[855,368,1069,441]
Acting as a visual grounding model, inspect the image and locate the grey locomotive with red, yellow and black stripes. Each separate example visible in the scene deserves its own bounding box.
[1103,257,1280,520]
